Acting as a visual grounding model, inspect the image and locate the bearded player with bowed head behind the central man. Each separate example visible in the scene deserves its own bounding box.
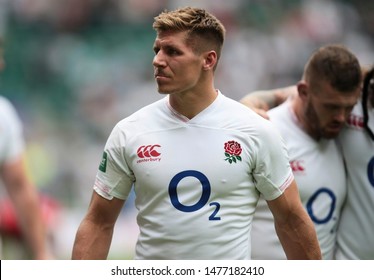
[244,45,361,259]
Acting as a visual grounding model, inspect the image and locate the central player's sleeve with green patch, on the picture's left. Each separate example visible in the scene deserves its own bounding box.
[94,122,135,200]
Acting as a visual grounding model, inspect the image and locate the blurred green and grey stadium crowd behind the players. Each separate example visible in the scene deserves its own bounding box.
[0,0,374,259]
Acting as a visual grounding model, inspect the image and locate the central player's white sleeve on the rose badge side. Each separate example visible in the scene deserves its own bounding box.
[253,122,294,200]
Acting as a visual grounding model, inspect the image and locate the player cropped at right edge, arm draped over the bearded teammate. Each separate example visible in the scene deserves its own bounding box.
[241,47,374,260]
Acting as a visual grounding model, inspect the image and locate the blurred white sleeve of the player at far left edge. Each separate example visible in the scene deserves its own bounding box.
[0,96,24,165]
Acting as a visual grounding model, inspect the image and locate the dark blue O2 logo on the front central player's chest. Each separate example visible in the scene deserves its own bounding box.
[169,170,221,221]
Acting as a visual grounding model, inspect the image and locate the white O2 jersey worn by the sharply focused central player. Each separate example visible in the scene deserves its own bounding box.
[94,92,293,259]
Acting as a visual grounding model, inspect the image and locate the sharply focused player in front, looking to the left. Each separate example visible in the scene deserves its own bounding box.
[72,7,321,259]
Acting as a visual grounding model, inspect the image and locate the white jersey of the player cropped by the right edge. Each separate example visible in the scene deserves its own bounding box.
[336,101,374,260]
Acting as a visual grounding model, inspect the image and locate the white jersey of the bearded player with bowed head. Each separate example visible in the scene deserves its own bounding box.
[252,102,346,259]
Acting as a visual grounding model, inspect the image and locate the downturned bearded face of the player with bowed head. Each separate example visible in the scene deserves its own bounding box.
[305,81,360,139]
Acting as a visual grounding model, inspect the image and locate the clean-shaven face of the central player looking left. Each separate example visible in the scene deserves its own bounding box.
[153,31,204,94]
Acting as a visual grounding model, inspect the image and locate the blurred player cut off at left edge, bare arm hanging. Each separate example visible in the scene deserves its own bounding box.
[0,38,51,259]
